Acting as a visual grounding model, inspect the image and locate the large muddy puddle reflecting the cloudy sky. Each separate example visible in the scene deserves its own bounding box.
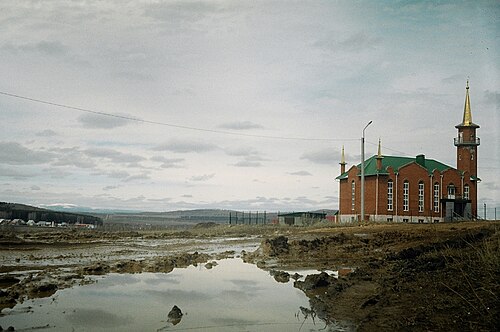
[0,259,348,331]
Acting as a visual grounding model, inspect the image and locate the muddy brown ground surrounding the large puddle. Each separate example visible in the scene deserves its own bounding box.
[0,222,500,331]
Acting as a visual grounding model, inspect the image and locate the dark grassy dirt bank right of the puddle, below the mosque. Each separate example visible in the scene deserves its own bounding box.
[245,222,500,331]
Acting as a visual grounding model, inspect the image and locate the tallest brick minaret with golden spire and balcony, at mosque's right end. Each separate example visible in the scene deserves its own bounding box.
[454,81,480,178]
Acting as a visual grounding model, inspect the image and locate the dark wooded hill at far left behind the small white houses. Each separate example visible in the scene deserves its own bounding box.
[0,202,102,225]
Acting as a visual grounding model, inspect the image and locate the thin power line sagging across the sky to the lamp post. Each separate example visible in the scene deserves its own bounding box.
[0,91,359,142]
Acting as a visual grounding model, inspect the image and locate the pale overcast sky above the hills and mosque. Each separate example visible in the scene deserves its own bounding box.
[0,0,500,214]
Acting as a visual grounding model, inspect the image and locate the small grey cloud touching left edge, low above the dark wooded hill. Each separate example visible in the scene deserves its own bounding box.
[0,142,54,165]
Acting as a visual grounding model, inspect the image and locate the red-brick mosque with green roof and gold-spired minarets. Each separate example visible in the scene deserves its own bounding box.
[336,81,480,223]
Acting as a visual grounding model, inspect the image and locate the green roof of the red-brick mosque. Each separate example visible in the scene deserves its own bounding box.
[336,155,453,180]
